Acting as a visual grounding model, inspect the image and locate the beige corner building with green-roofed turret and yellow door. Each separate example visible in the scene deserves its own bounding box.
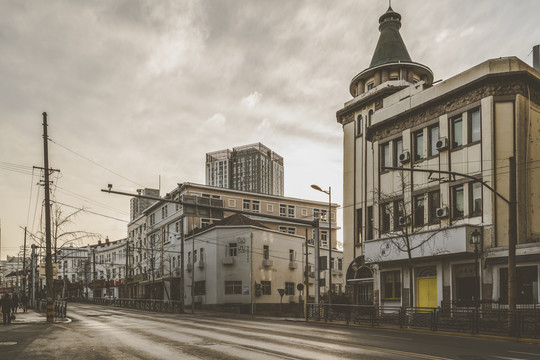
[337,8,540,308]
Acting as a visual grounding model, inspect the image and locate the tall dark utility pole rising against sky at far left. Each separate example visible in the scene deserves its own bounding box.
[43,112,54,322]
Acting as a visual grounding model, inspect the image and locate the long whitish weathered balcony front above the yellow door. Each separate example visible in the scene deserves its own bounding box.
[365,225,482,263]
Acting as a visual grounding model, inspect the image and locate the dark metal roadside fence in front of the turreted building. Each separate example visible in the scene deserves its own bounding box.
[307,304,540,339]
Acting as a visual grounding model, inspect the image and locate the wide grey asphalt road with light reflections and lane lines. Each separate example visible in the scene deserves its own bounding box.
[0,304,540,360]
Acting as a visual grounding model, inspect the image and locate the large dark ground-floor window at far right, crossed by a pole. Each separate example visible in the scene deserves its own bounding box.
[499,266,538,304]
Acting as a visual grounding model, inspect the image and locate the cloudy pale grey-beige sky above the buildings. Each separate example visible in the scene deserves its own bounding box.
[0,0,540,259]
